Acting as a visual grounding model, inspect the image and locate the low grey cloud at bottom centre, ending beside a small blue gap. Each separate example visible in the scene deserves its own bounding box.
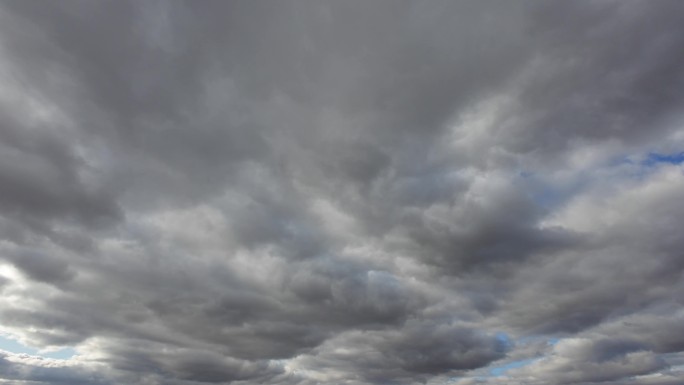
[294,320,507,383]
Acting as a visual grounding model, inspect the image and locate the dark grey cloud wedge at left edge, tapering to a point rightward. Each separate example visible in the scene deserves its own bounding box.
[0,99,121,230]
